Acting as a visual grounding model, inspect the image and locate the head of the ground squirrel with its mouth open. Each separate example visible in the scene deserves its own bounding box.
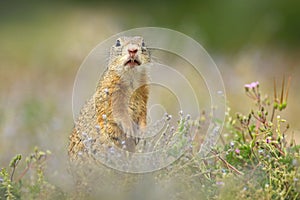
[109,36,150,70]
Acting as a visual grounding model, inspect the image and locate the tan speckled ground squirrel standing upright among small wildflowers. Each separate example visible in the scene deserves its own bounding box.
[68,37,150,160]
